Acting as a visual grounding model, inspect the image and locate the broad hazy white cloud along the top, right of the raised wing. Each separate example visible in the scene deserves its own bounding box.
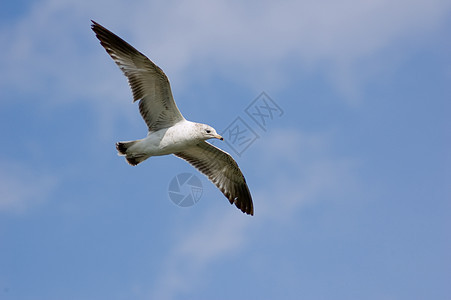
[108,0,451,96]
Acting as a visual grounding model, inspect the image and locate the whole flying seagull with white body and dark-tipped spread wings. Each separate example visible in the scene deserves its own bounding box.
[91,20,254,215]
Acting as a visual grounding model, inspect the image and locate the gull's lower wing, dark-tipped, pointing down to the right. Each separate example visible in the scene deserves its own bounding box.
[174,142,254,215]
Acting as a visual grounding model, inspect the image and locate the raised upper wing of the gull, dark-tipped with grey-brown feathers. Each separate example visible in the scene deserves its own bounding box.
[92,21,184,131]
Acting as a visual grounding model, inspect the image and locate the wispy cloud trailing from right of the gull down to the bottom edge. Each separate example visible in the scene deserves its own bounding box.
[151,129,358,299]
